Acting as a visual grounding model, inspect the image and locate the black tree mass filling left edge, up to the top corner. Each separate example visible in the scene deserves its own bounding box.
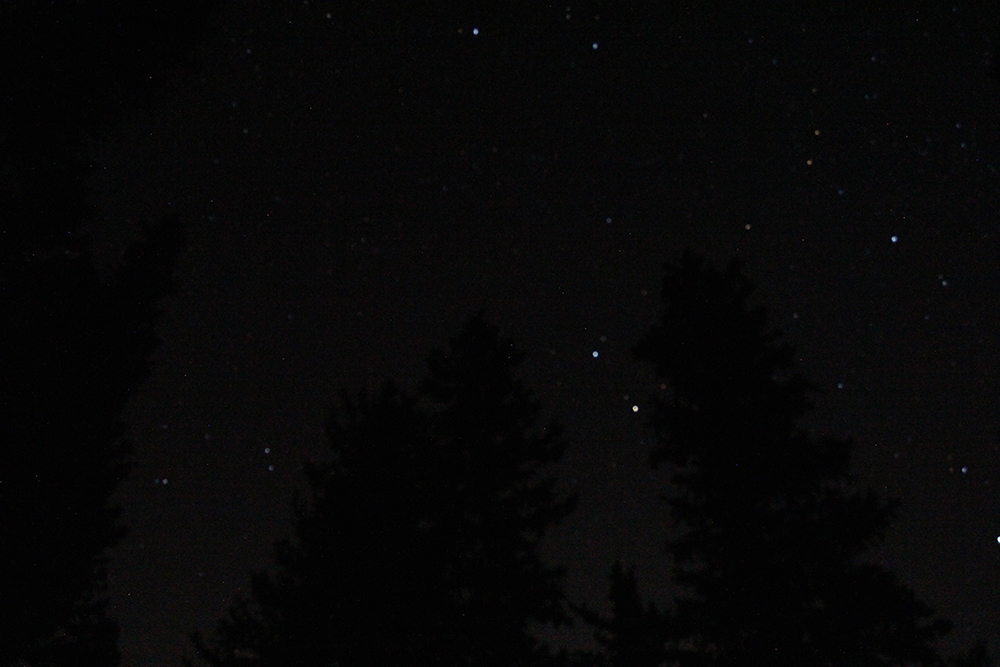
[0,0,220,667]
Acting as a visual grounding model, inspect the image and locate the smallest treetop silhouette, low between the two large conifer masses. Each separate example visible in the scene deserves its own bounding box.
[572,561,669,667]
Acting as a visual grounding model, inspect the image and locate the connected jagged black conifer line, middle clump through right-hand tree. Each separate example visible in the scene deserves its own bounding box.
[185,251,989,667]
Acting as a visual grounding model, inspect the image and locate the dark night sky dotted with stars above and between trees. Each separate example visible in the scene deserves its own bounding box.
[80,0,1000,666]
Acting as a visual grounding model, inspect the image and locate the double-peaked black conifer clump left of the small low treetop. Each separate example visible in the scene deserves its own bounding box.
[188,315,575,666]
